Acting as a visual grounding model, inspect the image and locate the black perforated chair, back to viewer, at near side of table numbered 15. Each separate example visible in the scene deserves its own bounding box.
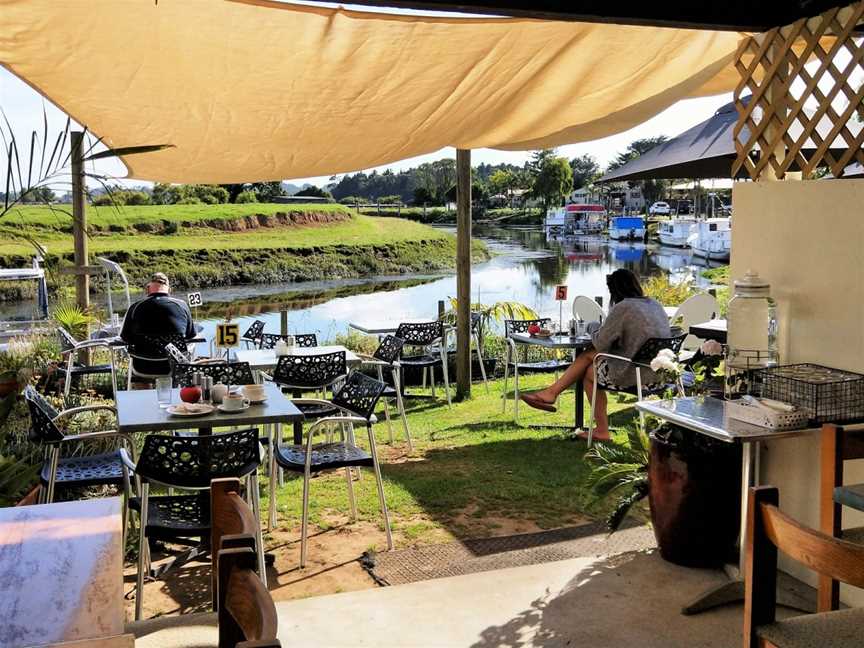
[130,428,265,620]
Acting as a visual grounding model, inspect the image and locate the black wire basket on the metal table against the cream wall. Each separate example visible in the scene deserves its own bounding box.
[754,363,864,423]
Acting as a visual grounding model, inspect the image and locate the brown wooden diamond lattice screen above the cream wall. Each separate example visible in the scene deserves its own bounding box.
[732,0,864,180]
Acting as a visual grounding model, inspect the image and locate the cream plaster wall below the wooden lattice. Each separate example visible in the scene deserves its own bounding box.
[730,180,864,606]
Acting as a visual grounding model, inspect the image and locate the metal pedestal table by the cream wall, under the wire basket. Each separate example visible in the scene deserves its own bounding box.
[636,396,836,614]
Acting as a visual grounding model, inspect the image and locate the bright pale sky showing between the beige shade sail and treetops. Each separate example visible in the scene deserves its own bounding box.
[0,49,732,191]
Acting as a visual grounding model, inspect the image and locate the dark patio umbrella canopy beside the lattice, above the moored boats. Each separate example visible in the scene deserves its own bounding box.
[598,97,749,182]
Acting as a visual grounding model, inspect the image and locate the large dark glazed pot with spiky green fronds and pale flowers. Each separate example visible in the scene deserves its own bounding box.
[586,345,741,567]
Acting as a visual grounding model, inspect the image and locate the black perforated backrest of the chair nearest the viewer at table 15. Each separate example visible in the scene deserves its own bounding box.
[135,428,261,488]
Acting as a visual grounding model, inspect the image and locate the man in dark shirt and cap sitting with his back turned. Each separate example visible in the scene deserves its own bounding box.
[120,272,195,377]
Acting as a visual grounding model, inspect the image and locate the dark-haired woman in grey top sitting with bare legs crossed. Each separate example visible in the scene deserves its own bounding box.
[520,268,671,440]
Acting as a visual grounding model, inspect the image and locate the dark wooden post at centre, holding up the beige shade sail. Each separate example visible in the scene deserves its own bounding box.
[456,149,471,398]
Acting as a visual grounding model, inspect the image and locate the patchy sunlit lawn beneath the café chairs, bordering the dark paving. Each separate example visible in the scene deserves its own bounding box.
[262,375,635,549]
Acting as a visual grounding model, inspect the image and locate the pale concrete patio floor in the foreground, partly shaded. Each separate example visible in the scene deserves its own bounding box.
[136,552,742,648]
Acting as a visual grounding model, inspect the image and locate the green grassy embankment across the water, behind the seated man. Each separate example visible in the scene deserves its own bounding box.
[0,204,487,287]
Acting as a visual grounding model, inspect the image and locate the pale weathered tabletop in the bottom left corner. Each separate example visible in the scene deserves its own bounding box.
[0,497,131,646]
